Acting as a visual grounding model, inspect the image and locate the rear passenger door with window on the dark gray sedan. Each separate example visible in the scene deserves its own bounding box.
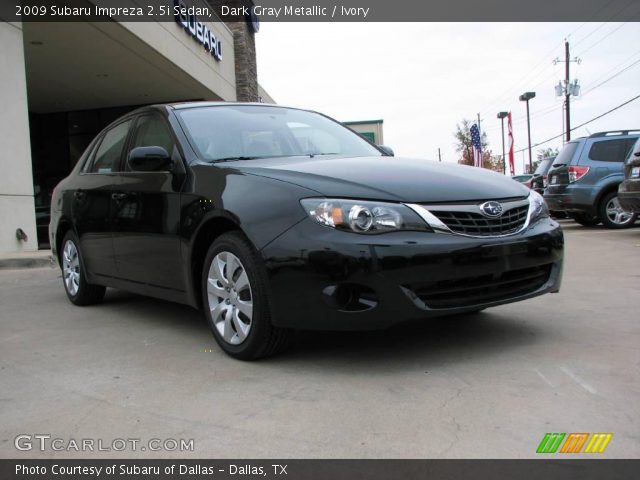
[71,119,131,277]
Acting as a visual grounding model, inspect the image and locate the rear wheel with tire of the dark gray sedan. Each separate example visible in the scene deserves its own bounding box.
[60,230,107,306]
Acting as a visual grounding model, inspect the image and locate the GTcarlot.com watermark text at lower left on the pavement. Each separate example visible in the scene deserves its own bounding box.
[13,433,194,452]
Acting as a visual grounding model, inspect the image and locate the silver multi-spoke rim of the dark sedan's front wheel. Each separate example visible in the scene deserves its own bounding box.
[207,251,253,345]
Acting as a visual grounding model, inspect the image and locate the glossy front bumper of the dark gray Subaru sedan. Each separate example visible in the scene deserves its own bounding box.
[261,219,564,330]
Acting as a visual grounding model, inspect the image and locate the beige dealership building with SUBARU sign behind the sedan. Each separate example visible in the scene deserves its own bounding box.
[0,0,272,254]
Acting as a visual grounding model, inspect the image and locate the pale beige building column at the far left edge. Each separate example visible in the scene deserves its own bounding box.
[0,22,38,254]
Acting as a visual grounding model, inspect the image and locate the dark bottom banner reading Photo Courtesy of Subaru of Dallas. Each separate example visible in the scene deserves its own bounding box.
[0,458,640,480]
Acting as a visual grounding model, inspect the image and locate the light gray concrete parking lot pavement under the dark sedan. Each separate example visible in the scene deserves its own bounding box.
[0,221,640,458]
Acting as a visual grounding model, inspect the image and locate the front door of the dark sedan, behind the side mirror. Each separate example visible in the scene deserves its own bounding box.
[111,113,185,291]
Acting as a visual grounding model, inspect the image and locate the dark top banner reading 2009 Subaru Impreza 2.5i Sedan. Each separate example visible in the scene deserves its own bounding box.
[0,0,640,22]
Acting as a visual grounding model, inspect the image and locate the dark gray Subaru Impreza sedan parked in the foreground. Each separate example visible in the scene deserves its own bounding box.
[50,102,563,359]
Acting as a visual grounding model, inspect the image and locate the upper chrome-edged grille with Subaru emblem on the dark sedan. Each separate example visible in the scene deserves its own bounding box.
[430,203,529,237]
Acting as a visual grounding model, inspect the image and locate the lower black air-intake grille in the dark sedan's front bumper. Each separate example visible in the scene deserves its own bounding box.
[404,264,552,309]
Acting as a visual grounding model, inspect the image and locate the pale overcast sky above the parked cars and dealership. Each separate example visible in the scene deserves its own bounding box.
[256,22,640,173]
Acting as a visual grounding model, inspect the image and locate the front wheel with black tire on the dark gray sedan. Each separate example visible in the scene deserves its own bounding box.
[202,232,291,360]
